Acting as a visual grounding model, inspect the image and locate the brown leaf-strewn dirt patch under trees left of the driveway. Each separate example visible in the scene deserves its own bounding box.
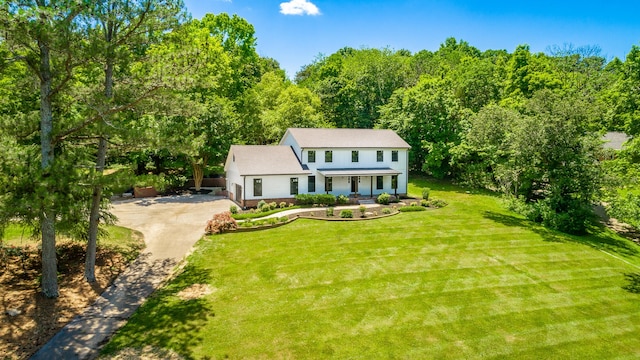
[0,240,142,359]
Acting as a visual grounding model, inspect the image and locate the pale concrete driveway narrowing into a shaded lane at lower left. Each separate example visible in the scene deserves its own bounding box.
[31,195,232,360]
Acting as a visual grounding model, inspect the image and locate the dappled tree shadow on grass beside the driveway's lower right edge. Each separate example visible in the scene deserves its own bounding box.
[102,264,215,359]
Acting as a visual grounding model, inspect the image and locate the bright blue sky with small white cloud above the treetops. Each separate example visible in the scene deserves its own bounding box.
[185,0,640,78]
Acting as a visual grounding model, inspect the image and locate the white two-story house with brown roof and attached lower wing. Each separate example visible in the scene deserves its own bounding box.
[225,128,410,207]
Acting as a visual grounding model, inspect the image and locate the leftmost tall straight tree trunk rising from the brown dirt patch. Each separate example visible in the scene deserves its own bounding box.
[38,36,59,298]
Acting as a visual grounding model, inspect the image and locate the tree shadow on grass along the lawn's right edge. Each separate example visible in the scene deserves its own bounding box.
[483,211,640,257]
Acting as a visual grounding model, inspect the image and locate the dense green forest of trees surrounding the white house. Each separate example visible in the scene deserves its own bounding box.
[0,0,640,297]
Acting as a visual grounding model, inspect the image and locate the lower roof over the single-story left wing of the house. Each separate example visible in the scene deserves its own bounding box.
[227,145,311,176]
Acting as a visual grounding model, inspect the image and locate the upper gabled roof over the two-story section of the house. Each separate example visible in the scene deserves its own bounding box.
[280,128,411,149]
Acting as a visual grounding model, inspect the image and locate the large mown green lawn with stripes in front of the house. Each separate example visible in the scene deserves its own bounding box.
[104,179,640,359]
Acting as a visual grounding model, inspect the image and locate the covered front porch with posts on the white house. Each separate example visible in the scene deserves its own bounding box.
[317,168,400,198]
